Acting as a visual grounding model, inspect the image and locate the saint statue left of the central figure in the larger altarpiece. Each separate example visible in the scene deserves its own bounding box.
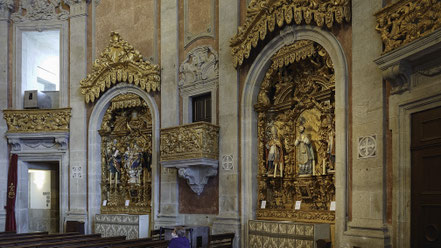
[265,126,284,177]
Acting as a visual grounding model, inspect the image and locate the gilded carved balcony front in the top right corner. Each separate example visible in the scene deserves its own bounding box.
[375,0,441,53]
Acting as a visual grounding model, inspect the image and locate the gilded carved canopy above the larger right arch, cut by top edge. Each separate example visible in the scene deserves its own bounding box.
[230,0,351,68]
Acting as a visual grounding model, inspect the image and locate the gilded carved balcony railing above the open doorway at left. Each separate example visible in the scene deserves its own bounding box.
[3,108,71,133]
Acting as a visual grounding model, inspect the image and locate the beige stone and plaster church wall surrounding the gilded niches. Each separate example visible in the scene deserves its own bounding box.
[0,0,441,247]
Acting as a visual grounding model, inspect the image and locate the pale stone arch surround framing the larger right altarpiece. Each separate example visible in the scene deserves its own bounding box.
[240,25,348,247]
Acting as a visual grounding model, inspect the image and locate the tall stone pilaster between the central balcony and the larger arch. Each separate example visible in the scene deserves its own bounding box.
[213,0,241,247]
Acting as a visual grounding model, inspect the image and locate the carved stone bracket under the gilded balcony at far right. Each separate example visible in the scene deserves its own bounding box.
[382,60,412,94]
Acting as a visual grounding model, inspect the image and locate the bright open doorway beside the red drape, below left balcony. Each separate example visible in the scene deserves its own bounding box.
[28,162,60,233]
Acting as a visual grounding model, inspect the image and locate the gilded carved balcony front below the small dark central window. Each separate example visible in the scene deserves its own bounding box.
[160,122,219,161]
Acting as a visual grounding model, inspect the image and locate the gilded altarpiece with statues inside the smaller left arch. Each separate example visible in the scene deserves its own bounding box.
[99,93,152,214]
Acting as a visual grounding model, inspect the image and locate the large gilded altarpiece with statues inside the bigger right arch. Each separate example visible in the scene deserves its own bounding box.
[254,40,335,223]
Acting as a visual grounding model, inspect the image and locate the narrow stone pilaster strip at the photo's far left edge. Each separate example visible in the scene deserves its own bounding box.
[0,0,13,231]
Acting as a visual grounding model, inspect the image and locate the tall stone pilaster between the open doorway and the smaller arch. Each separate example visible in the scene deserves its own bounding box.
[64,0,92,232]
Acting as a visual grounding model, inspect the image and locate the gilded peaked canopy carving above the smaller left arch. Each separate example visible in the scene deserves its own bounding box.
[80,32,161,103]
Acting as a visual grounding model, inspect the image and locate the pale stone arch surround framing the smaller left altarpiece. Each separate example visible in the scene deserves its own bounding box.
[88,83,160,233]
